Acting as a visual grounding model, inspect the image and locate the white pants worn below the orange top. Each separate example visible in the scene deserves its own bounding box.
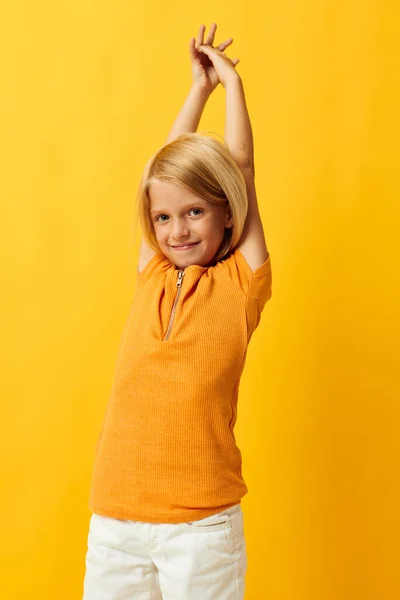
[83,504,247,600]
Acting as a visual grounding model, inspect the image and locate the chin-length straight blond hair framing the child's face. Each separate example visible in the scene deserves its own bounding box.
[137,132,248,264]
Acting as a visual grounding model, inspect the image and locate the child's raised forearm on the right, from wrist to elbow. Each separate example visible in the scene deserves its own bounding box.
[225,76,254,172]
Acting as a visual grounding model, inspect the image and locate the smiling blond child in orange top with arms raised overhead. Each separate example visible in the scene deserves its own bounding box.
[84,23,271,600]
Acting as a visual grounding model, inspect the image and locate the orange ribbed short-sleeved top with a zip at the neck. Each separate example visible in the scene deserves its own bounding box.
[89,248,272,523]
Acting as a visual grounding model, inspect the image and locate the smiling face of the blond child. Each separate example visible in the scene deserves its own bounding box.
[148,181,233,269]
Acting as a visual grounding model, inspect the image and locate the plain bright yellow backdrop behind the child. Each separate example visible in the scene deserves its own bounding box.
[0,0,400,600]
